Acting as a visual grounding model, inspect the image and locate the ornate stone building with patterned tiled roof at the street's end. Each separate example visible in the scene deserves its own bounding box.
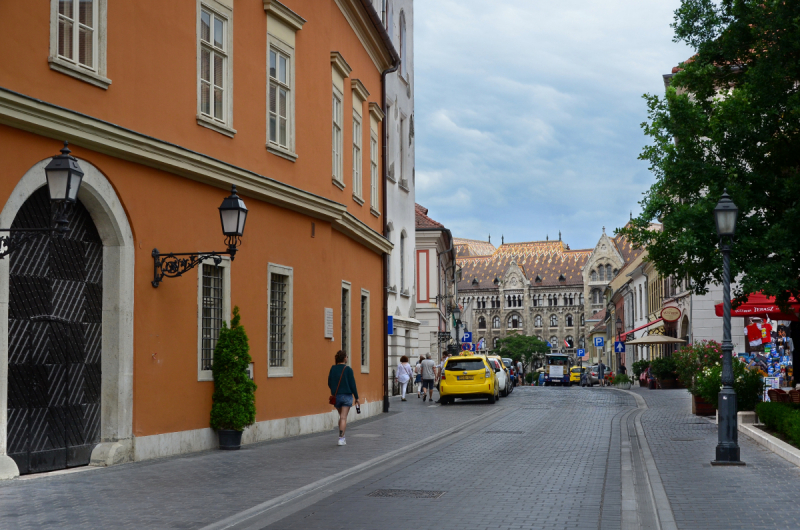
[455,230,638,354]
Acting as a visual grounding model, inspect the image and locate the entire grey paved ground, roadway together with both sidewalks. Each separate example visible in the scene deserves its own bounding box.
[0,387,800,530]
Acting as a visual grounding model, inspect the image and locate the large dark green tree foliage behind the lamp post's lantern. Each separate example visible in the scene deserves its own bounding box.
[620,0,800,303]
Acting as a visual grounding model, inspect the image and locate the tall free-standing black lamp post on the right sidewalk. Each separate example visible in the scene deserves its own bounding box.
[711,190,744,465]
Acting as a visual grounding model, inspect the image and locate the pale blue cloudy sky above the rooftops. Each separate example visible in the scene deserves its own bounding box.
[414,0,692,249]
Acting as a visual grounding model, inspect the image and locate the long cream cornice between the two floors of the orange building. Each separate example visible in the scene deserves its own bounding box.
[0,87,393,253]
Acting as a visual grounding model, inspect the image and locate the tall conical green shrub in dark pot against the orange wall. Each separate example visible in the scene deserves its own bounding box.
[211,307,256,450]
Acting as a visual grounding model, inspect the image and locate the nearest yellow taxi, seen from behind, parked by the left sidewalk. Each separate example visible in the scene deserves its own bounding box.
[439,354,500,405]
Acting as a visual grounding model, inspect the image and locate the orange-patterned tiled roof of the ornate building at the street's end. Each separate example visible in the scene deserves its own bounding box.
[458,241,592,292]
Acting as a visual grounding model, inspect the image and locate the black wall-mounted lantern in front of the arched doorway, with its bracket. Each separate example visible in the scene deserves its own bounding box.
[0,142,83,259]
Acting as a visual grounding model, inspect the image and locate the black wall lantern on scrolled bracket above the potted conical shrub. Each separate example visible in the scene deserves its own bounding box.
[152,185,247,287]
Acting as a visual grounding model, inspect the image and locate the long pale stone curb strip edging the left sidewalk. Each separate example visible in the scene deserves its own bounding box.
[201,402,508,530]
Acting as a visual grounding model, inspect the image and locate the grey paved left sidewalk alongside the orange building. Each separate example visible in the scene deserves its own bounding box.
[0,396,492,529]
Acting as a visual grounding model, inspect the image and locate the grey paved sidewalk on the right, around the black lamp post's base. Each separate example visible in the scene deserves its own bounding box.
[631,387,800,530]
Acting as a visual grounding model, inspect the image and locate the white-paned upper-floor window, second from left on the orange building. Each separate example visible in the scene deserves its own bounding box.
[200,10,227,121]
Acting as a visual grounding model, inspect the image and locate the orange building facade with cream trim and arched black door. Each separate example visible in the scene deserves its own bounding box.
[0,0,397,478]
